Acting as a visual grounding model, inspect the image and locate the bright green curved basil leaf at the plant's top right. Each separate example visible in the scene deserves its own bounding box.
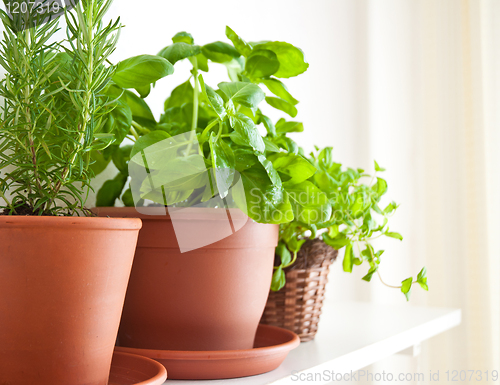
[253,41,309,78]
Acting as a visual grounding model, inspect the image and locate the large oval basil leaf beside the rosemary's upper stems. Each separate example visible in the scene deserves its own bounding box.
[113,55,174,88]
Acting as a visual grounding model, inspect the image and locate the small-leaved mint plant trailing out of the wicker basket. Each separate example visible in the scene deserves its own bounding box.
[272,147,428,300]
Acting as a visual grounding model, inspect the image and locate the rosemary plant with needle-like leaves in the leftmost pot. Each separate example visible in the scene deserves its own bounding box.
[0,0,120,215]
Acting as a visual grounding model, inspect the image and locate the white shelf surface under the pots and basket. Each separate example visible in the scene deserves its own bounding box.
[166,302,462,385]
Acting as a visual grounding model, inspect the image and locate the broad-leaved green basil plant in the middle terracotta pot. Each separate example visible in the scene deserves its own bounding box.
[93,27,314,223]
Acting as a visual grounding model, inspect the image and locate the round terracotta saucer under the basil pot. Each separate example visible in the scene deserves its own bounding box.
[116,325,300,380]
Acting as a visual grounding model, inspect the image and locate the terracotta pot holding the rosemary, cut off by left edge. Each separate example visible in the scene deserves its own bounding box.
[0,216,141,385]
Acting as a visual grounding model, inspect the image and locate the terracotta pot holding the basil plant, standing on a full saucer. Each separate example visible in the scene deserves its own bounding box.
[97,208,279,352]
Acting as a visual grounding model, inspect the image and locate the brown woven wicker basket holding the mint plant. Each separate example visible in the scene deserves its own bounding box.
[260,260,332,342]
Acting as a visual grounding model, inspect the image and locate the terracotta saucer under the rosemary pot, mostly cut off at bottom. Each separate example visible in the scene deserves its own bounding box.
[108,350,167,385]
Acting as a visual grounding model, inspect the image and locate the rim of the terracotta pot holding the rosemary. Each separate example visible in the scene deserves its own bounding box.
[0,215,142,230]
